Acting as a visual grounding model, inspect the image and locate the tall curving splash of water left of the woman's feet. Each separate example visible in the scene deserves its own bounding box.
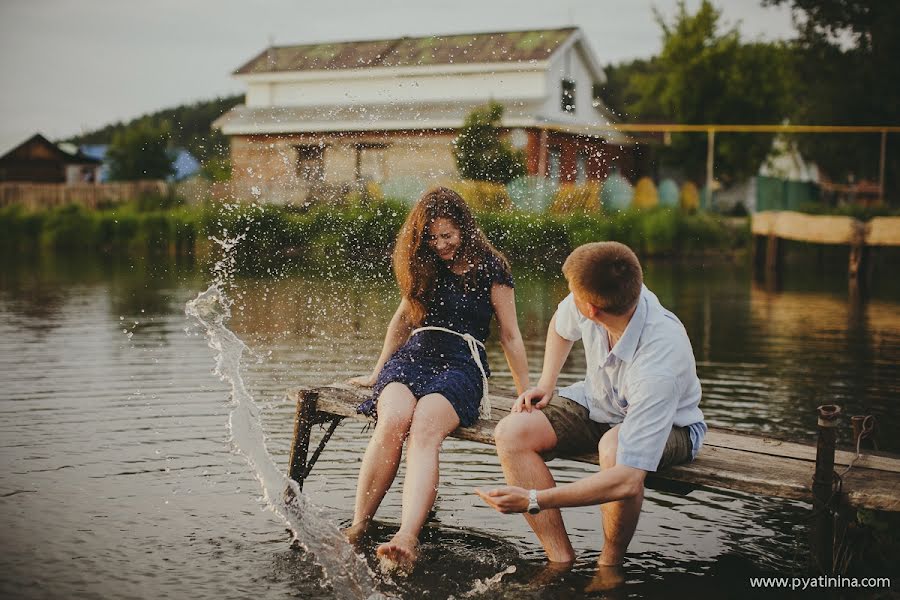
[185,284,385,599]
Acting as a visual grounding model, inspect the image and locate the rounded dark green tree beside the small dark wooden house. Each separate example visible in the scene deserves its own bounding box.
[107,120,175,181]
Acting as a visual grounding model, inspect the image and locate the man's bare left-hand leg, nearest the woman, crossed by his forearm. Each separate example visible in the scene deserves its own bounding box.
[494,410,575,563]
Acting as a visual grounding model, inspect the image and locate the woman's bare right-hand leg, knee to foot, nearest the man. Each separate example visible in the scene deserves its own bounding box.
[377,394,459,570]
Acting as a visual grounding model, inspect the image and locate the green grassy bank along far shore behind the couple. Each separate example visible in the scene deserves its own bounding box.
[0,201,749,273]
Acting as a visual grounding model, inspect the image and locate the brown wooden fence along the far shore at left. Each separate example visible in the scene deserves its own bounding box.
[0,180,169,210]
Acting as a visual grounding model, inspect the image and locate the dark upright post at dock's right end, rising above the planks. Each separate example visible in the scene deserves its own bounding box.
[810,404,841,575]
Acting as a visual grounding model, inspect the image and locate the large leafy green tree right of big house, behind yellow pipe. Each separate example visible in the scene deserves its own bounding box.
[604,0,790,182]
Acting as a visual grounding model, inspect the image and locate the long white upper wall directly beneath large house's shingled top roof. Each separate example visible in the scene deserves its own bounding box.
[246,69,547,107]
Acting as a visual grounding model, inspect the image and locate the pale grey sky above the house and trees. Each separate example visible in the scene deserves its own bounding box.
[0,0,795,154]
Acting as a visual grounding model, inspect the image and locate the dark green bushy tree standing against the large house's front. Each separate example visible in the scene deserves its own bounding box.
[453,102,526,184]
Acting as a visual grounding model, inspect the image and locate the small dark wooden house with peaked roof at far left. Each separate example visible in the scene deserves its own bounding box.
[0,133,101,184]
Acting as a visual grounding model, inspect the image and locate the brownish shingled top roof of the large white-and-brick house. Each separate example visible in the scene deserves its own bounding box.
[234,27,576,75]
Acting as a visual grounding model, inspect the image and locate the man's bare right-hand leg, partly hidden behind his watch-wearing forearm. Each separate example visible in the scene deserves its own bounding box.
[597,425,644,567]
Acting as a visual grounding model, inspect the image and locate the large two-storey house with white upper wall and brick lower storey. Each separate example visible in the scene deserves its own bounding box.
[213,28,632,202]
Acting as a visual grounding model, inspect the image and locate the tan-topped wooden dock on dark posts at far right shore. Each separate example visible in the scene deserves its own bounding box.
[750,211,900,287]
